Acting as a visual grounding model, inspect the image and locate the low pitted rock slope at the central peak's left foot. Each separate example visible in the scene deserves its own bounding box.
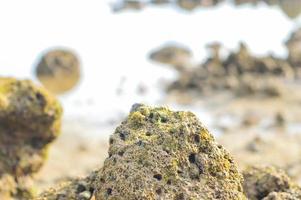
[35,172,96,200]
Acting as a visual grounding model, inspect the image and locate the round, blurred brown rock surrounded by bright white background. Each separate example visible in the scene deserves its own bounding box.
[36,49,80,94]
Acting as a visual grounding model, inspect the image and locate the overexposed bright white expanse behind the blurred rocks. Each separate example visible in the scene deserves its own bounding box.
[0,0,301,134]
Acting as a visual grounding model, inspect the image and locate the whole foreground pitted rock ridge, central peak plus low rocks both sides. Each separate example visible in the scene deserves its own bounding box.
[31,104,301,200]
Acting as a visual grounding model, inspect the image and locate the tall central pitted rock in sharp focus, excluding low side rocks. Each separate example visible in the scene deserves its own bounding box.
[95,105,245,200]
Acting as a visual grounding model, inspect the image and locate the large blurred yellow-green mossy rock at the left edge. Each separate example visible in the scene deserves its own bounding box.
[0,78,62,177]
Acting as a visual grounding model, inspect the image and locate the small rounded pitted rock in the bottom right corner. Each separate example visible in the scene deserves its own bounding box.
[243,167,301,200]
